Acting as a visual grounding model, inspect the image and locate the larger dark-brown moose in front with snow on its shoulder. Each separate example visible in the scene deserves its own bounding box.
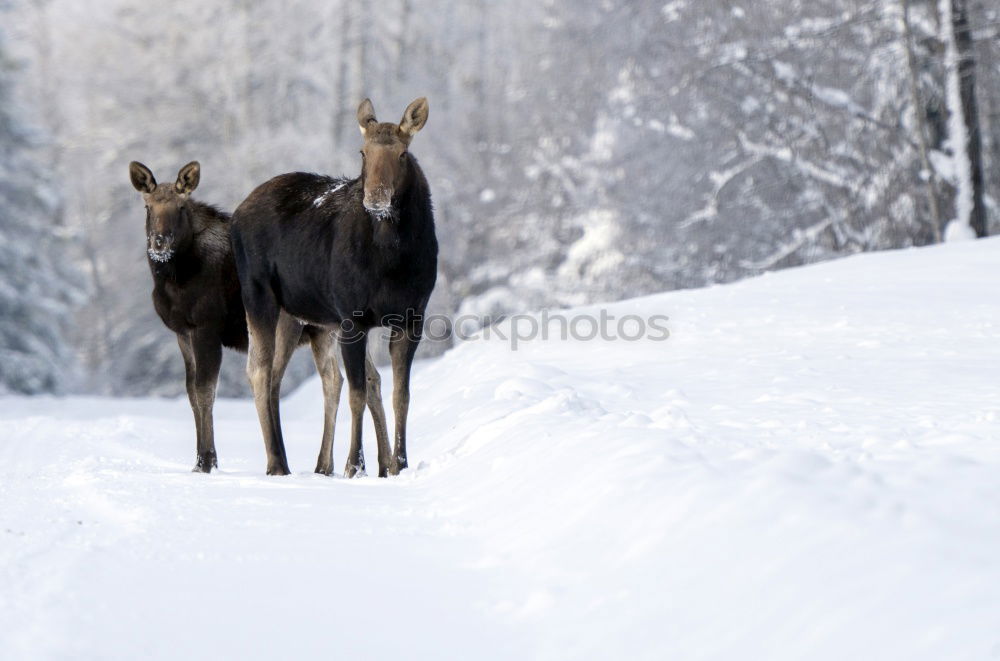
[232,98,438,477]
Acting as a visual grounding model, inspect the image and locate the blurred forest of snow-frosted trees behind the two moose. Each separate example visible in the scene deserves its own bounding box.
[0,0,1000,395]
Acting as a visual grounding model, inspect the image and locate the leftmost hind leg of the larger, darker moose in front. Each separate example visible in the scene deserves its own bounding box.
[244,304,290,475]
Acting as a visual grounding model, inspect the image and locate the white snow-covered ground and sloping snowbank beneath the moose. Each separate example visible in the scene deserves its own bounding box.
[0,239,1000,661]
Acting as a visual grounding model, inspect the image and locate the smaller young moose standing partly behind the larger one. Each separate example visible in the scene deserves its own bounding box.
[129,161,384,473]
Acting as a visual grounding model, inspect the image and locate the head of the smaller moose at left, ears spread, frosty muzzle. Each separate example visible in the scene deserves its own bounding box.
[128,161,201,262]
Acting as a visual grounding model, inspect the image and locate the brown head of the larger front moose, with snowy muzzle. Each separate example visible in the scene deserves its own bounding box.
[358,97,427,219]
